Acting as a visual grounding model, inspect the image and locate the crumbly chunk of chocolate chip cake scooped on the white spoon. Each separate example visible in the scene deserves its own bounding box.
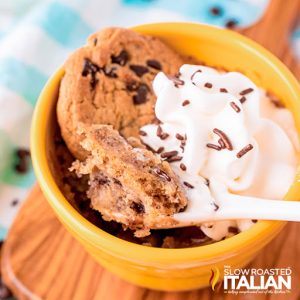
[71,125,187,237]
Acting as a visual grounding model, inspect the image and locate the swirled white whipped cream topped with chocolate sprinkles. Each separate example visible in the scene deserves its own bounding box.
[141,65,298,240]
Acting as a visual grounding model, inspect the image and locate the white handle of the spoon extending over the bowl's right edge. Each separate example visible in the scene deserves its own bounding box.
[213,195,300,221]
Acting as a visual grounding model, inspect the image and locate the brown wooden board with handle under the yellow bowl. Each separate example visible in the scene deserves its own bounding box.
[1,0,300,300]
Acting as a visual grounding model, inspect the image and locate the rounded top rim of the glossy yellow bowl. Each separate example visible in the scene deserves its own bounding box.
[31,22,300,263]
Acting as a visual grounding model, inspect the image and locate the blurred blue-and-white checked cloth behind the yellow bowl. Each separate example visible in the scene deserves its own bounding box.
[0,0,300,258]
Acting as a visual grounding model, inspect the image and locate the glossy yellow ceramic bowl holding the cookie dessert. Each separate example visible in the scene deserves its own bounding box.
[31,23,300,291]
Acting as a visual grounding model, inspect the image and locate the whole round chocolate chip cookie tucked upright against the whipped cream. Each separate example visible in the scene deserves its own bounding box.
[57,28,184,160]
